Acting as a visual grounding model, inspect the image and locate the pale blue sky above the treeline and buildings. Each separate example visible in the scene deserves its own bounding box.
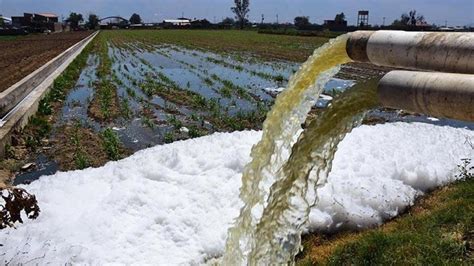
[0,0,474,26]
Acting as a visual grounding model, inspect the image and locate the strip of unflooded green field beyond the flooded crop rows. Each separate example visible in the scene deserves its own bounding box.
[101,30,329,62]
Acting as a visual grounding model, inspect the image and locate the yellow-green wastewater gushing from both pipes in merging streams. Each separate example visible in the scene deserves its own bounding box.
[222,35,382,265]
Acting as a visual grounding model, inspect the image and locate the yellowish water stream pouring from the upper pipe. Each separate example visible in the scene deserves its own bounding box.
[222,35,360,265]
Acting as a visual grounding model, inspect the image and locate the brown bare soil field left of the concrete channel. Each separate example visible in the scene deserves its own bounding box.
[0,32,90,92]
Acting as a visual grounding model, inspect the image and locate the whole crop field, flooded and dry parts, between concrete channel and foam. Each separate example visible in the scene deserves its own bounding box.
[1,31,353,183]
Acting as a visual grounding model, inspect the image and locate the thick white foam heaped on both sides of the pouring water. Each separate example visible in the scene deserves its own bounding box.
[0,123,474,265]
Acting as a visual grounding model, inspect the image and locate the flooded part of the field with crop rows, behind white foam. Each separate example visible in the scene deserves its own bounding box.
[9,32,354,183]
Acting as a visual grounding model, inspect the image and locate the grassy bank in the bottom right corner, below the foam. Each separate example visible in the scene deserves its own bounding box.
[297,178,474,265]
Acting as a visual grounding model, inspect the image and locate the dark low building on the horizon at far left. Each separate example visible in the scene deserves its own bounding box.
[12,13,62,32]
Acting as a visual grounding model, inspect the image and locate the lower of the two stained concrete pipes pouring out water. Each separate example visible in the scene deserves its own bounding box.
[378,71,474,122]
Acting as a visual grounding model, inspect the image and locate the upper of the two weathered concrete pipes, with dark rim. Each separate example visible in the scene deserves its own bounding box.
[346,31,474,74]
